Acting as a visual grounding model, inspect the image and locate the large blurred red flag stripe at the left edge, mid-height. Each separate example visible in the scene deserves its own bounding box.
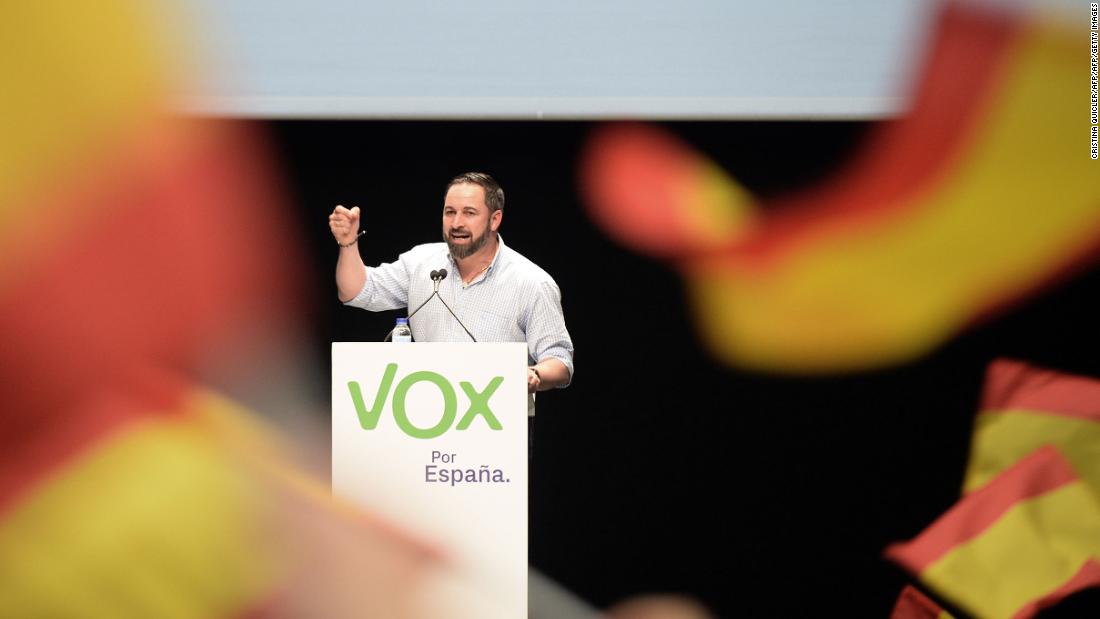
[0,123,300,428]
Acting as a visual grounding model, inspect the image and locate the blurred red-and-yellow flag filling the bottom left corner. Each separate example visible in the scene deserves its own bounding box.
[0,371,288,617]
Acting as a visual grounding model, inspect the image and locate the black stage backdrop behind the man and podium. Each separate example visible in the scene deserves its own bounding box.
[268,121,1100,617]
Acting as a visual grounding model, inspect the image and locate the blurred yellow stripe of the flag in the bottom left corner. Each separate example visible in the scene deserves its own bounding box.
[0,398,281,618]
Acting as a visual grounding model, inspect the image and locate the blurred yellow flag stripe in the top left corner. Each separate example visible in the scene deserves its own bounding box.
[0,0,173,249]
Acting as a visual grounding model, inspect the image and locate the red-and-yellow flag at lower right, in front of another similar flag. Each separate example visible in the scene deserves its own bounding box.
[887,446,1100,618]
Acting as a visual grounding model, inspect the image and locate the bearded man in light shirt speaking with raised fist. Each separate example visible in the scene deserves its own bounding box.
[329,172,573,422]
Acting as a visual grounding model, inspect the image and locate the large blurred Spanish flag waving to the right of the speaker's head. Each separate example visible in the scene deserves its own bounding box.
[580,0,1100,373]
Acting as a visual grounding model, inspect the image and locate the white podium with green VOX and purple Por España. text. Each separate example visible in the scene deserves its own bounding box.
[332,342,528,617]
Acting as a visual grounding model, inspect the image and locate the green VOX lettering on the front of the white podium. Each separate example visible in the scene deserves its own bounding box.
[348,363,504,439]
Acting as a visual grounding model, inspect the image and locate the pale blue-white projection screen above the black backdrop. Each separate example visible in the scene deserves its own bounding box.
[184,0,934,120]
